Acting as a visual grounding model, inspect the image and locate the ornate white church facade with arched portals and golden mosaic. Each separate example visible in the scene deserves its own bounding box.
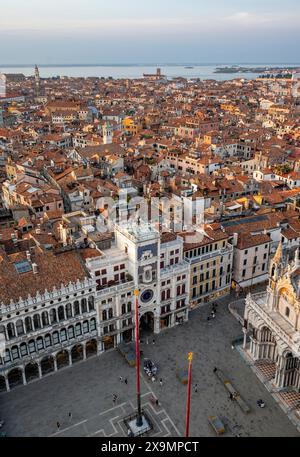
[243,244,300,392]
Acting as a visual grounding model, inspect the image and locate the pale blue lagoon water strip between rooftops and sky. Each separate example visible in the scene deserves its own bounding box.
[0,63,300,81]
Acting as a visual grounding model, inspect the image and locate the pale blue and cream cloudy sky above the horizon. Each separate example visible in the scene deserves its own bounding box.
[0,0,300,65]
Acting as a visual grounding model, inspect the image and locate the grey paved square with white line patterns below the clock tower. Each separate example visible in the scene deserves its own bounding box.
[0,297,299,437]
